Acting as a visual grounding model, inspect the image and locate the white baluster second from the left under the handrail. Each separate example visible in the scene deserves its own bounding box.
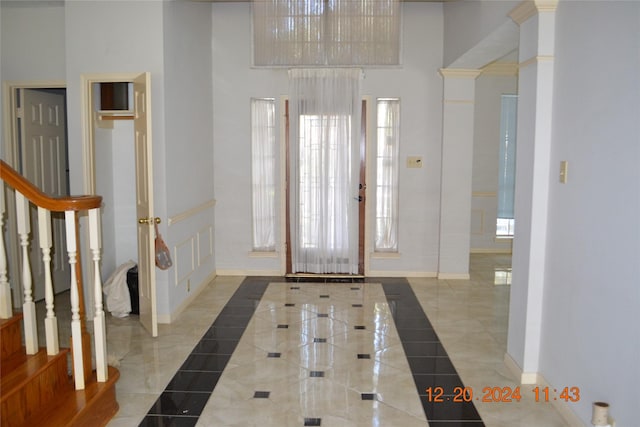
[16,191,38,354]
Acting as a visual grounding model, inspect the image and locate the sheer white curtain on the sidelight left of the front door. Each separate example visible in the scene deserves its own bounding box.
[251,98,276,251]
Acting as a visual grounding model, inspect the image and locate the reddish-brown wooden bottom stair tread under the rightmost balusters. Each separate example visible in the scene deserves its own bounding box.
[25,366,120,427]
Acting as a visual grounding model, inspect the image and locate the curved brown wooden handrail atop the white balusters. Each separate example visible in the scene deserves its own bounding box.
[0,160,102,212]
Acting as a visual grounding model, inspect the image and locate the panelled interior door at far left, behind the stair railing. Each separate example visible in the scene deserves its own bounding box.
[16,89,71,300]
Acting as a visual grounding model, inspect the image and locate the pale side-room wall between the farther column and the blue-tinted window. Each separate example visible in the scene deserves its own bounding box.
[471,72,517,252]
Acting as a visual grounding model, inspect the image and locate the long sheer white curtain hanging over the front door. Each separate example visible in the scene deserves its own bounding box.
[289,69,362,274]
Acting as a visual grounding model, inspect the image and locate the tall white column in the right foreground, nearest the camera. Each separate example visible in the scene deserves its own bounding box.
[505,0,557,384]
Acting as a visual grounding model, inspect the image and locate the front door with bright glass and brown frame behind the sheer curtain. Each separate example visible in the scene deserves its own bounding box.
[285,101,366,275]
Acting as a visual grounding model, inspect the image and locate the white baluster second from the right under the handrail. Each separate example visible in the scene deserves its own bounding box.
[64,211,84,390]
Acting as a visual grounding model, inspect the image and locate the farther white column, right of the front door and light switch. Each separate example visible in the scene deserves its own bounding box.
[438,68,481,279]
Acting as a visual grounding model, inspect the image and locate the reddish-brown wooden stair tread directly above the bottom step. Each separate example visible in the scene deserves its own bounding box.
[0,348,69,394]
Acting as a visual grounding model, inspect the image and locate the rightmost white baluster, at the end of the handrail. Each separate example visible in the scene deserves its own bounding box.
[89,208,109,382]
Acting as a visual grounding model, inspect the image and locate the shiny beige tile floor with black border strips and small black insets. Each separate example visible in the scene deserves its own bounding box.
[108,255,566,427]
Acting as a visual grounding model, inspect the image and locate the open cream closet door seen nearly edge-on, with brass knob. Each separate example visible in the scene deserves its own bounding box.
[133,73,158,337]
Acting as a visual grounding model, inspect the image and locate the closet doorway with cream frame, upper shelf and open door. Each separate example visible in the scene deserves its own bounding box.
[81,73,158,336]
